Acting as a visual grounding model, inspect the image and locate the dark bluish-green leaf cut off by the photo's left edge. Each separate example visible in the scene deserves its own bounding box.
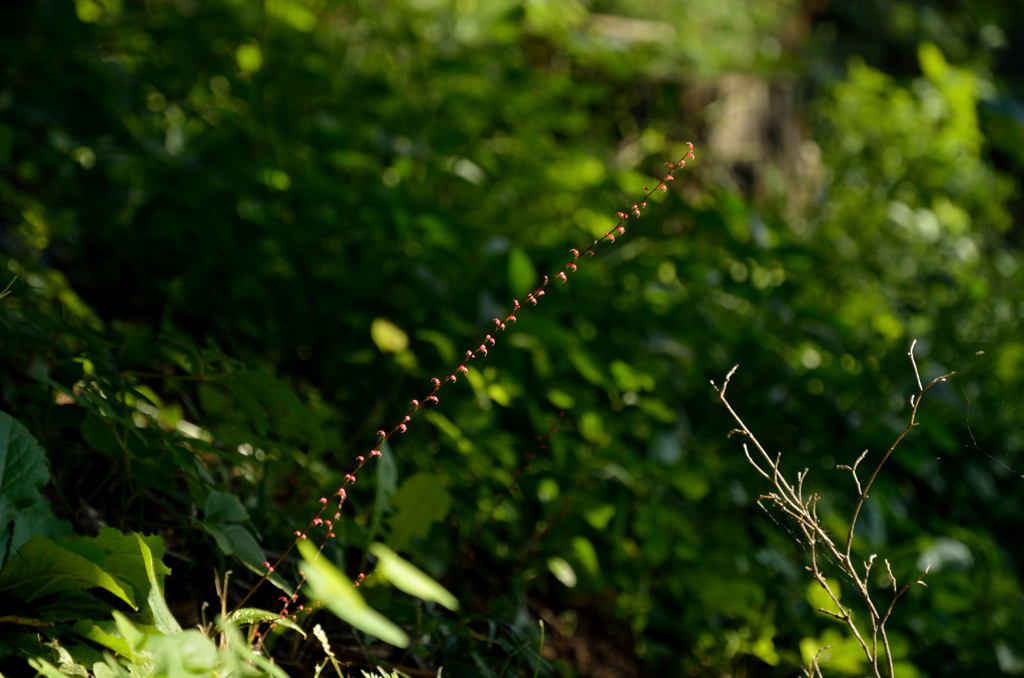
[0,412,50,565]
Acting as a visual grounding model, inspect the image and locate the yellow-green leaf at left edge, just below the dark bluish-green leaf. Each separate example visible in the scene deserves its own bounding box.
[0,537,137,609]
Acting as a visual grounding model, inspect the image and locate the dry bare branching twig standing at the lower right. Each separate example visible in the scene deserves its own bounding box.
[711,346,955,678]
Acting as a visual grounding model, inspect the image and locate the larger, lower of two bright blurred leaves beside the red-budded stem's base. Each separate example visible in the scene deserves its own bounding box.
[299,540,409,647]
